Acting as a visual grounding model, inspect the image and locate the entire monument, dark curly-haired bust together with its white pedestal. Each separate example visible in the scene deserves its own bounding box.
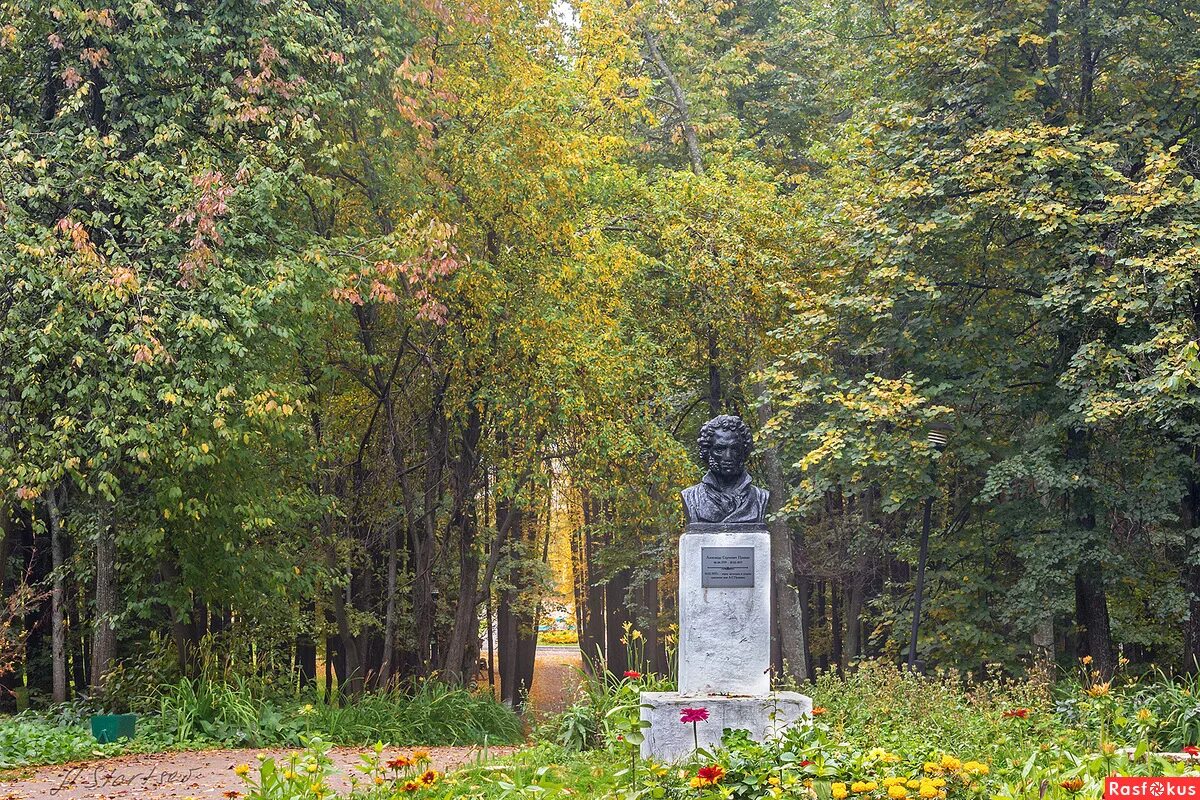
[642,415,812,762]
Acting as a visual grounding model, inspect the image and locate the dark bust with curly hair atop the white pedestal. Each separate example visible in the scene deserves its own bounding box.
[682,414,769,524]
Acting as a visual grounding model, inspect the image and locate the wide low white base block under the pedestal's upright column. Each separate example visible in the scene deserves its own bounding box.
[642,692,812,762]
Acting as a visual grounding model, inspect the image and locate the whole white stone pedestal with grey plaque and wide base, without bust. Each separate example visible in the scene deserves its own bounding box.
[641,523,812,762]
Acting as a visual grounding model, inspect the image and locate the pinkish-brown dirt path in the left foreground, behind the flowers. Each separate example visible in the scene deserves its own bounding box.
[0,747,517,800]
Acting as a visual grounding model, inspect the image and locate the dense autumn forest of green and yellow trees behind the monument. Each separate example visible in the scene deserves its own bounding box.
[0,0,1200,703]
